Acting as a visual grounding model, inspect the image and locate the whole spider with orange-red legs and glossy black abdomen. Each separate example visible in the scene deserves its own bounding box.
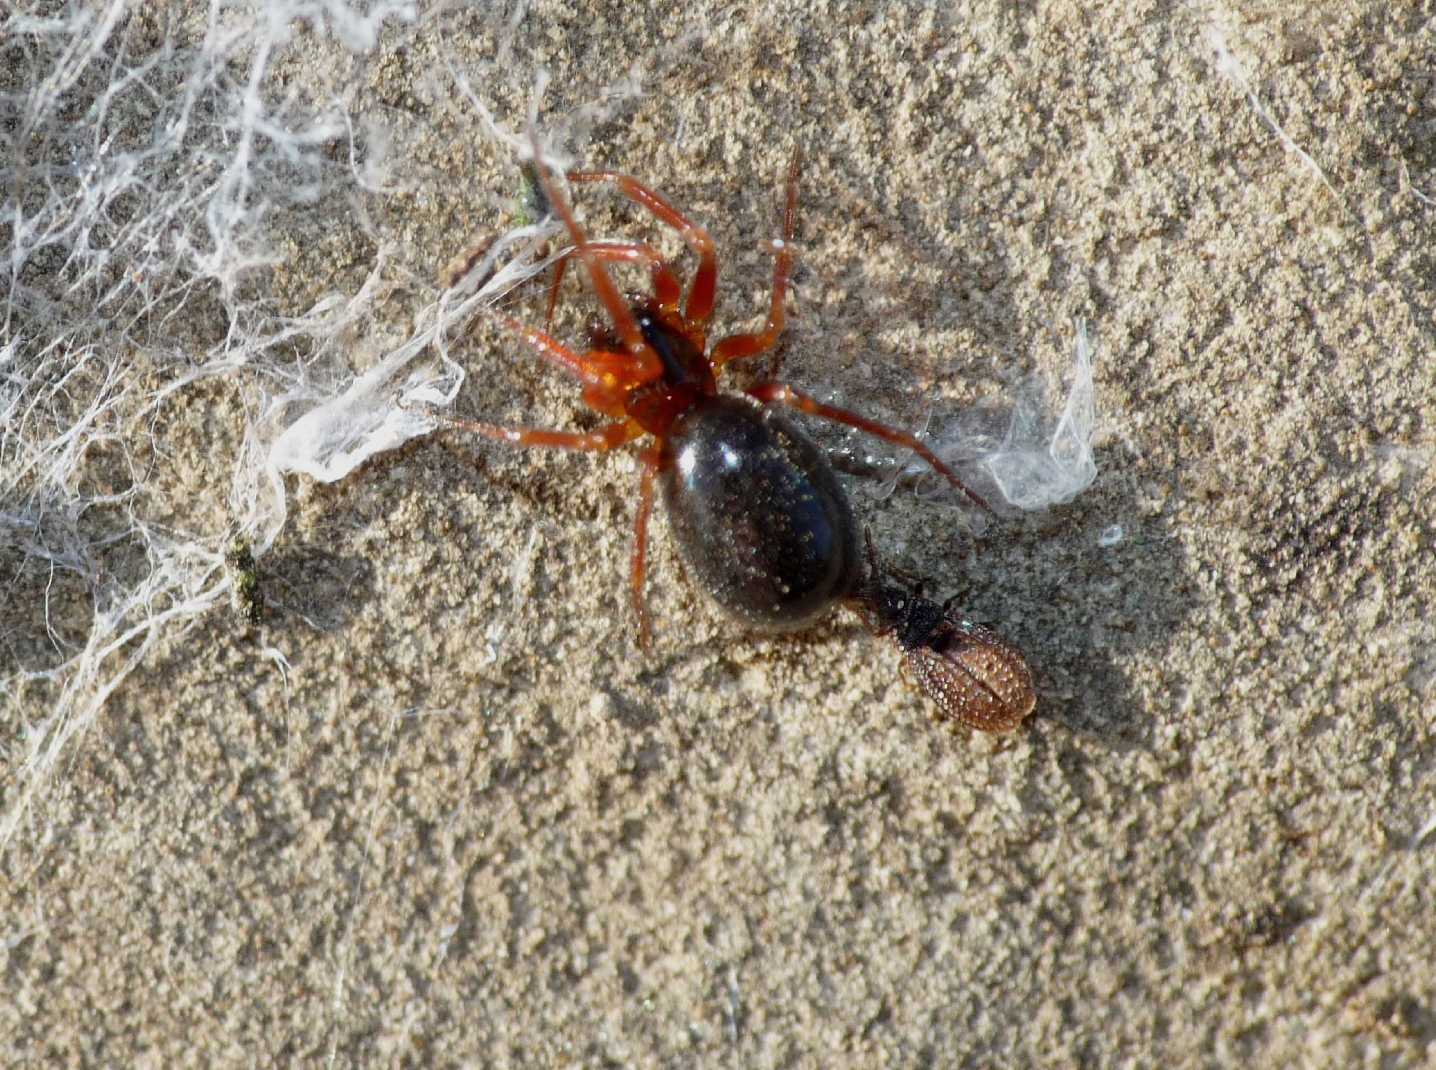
[445,144,989,646]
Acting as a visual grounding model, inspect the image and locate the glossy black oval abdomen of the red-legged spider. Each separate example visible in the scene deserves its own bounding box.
[659,396,860,631]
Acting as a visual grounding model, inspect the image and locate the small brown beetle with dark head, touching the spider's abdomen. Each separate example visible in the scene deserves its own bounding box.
[856,537,1037,732]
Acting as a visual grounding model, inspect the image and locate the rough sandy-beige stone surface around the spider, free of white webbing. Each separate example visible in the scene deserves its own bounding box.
[0,0,1436,1067]
